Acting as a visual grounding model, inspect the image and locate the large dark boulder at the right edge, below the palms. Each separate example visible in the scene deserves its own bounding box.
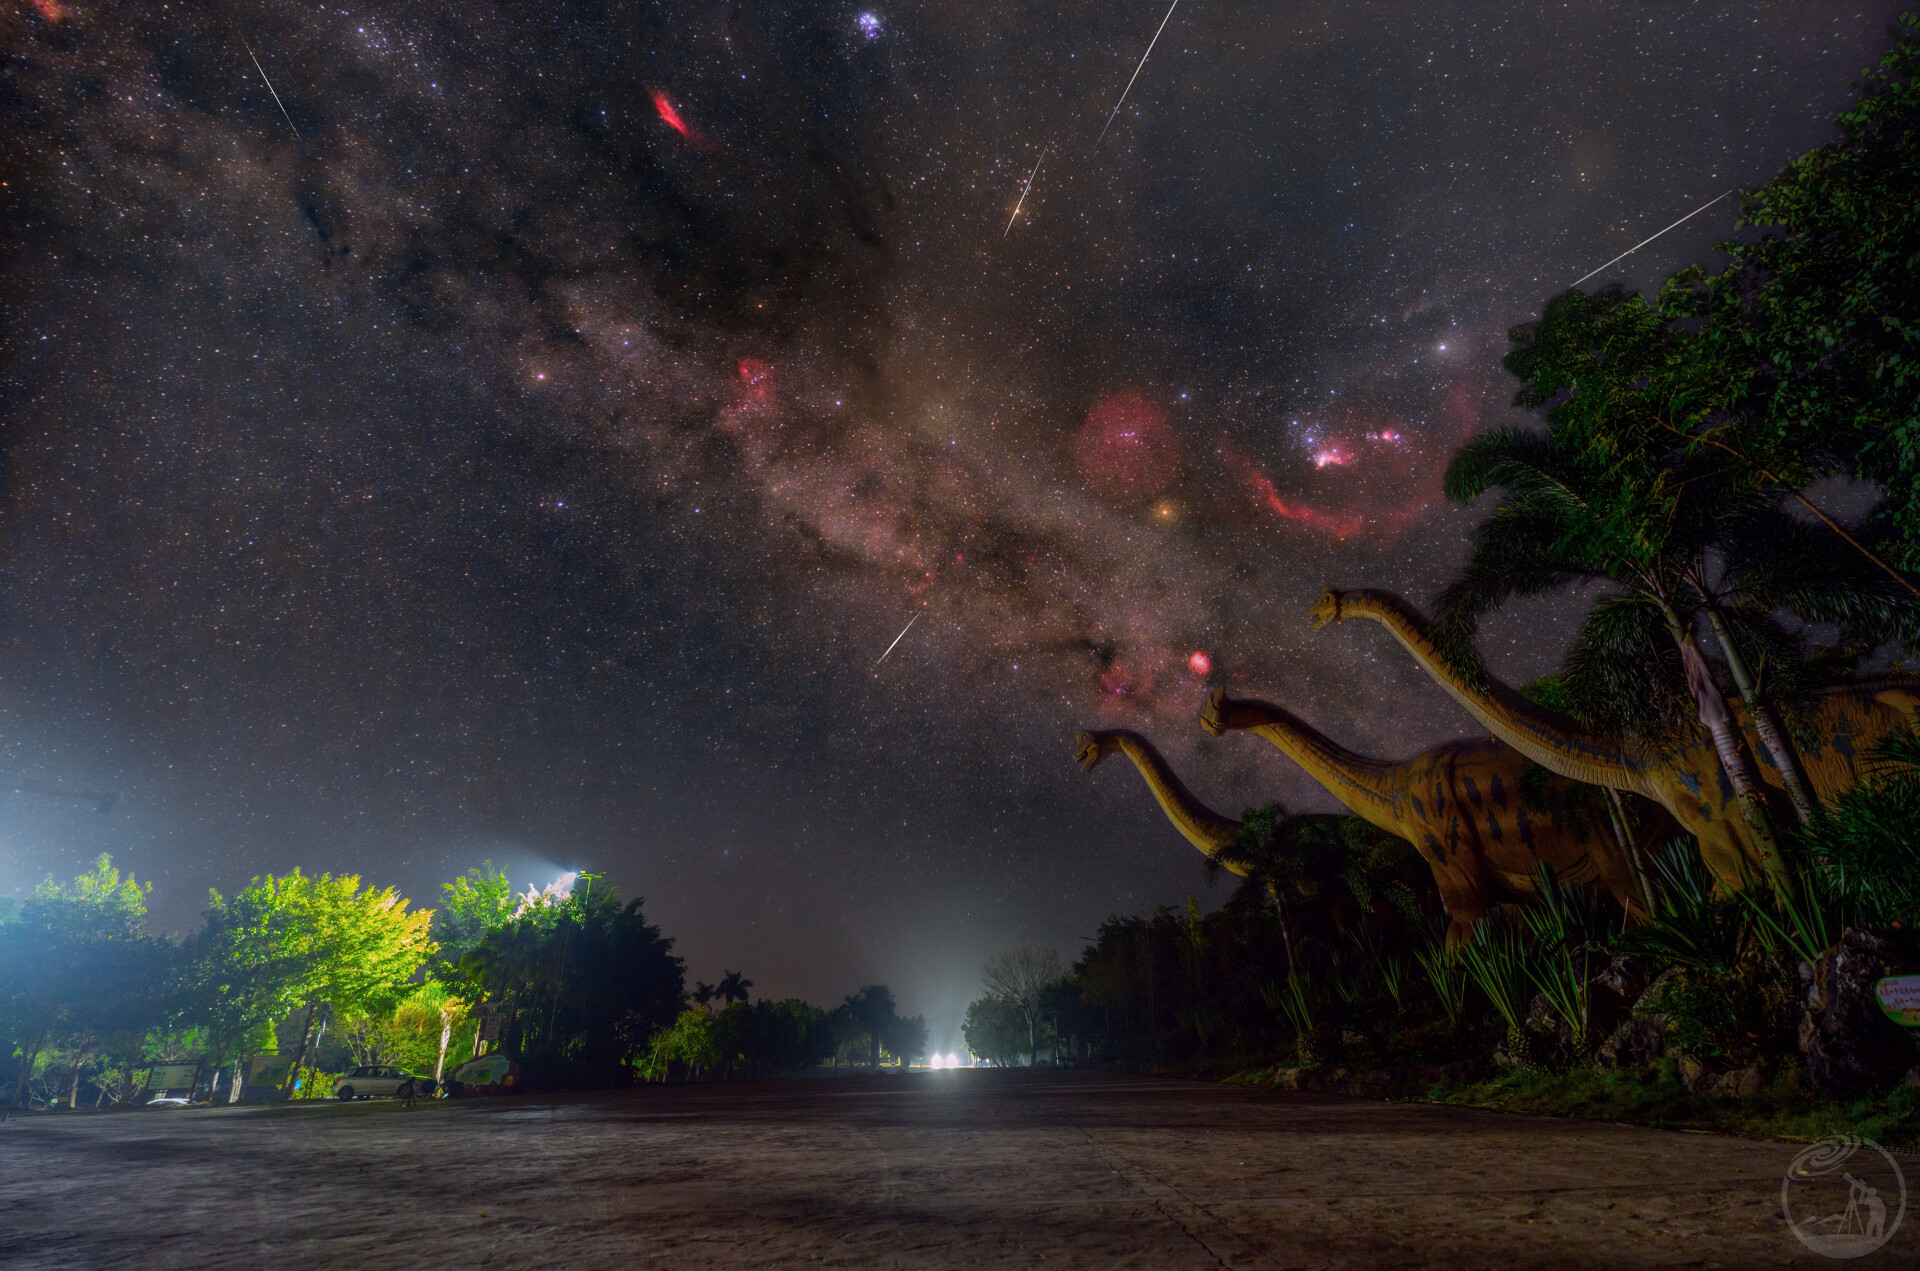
[1799,927,1916,1098]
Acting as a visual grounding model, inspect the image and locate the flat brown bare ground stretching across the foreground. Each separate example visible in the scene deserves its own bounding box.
[0,1071,1920,1271]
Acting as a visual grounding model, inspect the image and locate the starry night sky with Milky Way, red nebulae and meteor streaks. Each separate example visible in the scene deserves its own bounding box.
[0,0,1899,1044]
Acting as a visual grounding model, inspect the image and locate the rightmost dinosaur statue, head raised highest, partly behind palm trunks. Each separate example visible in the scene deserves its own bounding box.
[1311,588,1920,887]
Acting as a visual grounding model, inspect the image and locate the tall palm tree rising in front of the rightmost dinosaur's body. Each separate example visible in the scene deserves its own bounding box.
[1436,290,1805,872]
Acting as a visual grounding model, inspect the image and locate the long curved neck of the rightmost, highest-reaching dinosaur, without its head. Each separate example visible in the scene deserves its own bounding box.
[1336,591,1657,797]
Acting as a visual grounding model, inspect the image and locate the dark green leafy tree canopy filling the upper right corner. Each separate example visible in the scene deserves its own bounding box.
[1661,15,1920,568]
